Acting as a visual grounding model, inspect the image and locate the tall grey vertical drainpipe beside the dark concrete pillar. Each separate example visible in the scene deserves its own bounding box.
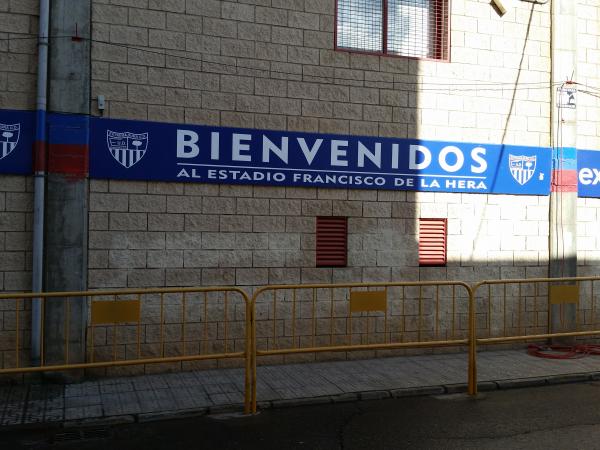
[31,0,50,366]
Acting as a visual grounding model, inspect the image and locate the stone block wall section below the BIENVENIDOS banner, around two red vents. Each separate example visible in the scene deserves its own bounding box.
[89,180,548,370]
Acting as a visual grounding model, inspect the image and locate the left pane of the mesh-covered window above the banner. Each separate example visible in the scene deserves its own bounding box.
[337,0,383,52]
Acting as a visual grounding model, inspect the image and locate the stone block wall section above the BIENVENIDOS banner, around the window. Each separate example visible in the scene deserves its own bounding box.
[92,0,550,145]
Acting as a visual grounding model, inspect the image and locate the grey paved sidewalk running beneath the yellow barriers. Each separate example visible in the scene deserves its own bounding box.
[0,350,600,426]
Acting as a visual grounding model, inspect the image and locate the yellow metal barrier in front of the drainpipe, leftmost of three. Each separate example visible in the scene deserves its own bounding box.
[0,287,252,413]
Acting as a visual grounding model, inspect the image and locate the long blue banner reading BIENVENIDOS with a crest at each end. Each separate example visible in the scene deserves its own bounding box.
[90,118,551,195]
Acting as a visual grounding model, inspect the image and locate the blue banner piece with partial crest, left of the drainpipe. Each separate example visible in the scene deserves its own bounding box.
[0,110,35,175]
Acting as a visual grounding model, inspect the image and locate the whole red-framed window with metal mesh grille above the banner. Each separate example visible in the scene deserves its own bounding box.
[336,0,449,60]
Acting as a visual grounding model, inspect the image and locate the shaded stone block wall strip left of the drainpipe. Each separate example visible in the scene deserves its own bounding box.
[0,0,39,367]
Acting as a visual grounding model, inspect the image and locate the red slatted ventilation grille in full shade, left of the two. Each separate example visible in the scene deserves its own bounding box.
[316,217,348,267]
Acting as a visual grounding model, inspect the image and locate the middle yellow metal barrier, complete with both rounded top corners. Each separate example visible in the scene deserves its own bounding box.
[251,281,474,411]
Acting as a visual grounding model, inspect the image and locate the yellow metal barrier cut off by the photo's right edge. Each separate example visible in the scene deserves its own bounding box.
[469,277,600,395]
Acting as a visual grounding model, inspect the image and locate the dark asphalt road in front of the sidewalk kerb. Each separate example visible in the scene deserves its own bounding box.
[0,382,600,450]
